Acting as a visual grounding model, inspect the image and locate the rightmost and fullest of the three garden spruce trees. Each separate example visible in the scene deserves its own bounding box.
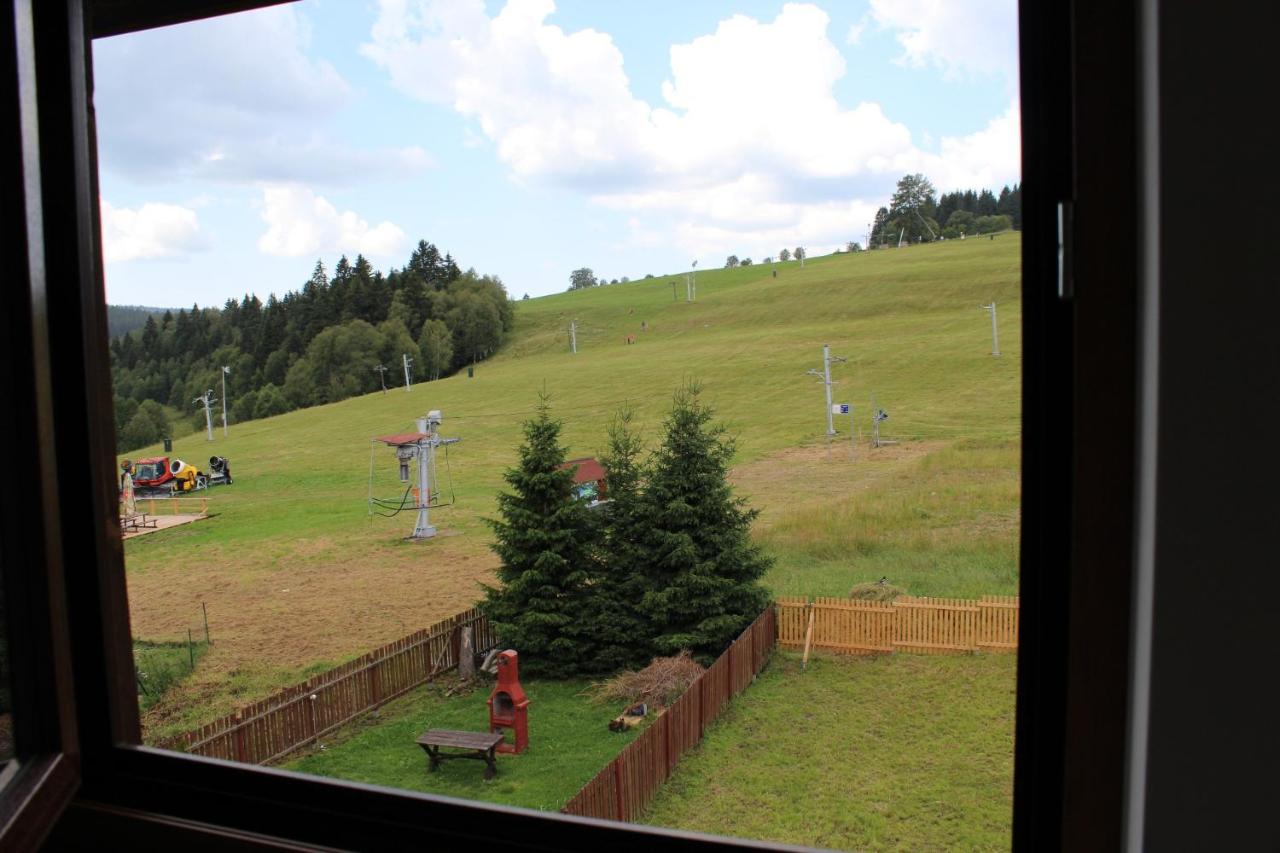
[640,384,771,662]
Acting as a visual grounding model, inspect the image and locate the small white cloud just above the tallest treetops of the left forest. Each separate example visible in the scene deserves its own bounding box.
[257,186,406,257]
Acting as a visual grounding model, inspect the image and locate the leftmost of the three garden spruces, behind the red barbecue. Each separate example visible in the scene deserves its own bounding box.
[481,396,595,678]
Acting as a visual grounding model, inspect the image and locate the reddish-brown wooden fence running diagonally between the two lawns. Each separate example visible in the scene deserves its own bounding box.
[561,607,777,821]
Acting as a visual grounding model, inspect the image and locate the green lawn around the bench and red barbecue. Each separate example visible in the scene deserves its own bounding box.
[284,680,640,811]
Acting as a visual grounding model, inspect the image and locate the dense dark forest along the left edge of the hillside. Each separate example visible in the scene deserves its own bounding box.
[111,241,515,452]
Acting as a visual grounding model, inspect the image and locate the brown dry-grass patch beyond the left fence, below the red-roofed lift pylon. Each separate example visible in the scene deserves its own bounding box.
[128,530,498,729]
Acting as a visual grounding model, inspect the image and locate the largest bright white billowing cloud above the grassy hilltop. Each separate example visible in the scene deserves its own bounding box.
[361,0,1020,255]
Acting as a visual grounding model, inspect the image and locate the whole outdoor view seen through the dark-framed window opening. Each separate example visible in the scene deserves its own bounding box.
[93,0,1021,849]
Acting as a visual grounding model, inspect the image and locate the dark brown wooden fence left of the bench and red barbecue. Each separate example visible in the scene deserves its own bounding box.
[160,608,497,765]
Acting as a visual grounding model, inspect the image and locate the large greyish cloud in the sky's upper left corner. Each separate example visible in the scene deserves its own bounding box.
[93,6,428,184]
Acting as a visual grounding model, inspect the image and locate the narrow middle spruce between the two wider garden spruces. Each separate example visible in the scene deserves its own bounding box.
[584,409,653,672]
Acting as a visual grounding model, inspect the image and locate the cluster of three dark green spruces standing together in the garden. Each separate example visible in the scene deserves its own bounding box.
[481,386,771,678]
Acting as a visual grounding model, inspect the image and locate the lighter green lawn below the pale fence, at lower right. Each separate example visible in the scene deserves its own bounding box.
[644,653,1016,850]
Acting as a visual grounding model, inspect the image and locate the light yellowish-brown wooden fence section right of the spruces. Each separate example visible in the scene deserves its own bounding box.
[777,596,1018,654]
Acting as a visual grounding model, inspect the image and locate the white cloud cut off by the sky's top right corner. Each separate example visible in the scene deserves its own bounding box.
[870,0,1018,86]
